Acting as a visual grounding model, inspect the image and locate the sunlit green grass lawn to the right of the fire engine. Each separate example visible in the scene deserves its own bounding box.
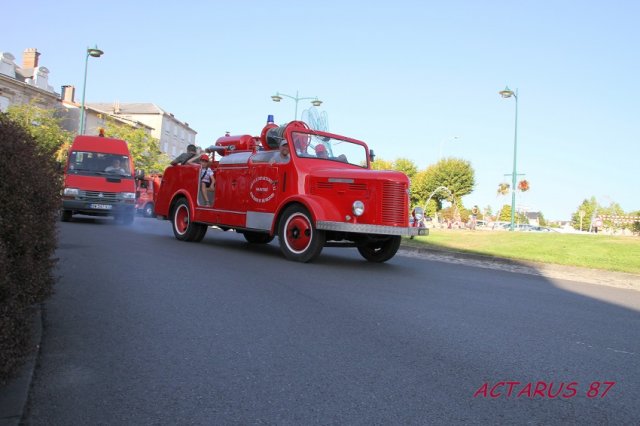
[403,229,640,274]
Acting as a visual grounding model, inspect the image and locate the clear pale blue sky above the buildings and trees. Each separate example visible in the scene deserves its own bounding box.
[0,0,640,219]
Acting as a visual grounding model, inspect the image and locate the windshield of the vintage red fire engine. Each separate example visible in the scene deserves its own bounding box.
[292,132,367,168]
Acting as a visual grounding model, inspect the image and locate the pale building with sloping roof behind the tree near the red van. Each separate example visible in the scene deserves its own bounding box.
[87,102,197,157]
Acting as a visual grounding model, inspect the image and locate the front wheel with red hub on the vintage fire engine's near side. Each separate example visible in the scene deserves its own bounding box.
[278,204,326,262]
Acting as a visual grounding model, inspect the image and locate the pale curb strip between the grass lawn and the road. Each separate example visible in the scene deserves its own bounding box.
[398,244,640,291]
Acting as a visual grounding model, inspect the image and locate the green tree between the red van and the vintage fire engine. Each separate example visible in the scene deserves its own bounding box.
[105,120,170,173]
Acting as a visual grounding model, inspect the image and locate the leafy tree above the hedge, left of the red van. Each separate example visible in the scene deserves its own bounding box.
[7,102,73,162]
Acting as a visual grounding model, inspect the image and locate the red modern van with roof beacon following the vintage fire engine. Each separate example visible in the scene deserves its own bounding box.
[61,136,136,224]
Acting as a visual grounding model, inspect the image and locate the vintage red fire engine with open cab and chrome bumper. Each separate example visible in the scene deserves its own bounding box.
[155,116,428,262]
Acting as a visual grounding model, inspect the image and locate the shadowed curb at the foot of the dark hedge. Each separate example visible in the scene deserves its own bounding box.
[0,305,42,426]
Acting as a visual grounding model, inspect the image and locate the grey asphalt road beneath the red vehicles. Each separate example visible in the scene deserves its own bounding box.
[24,218,640,425]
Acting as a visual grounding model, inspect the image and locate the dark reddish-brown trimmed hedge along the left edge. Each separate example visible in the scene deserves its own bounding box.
[0,113,61,385]
